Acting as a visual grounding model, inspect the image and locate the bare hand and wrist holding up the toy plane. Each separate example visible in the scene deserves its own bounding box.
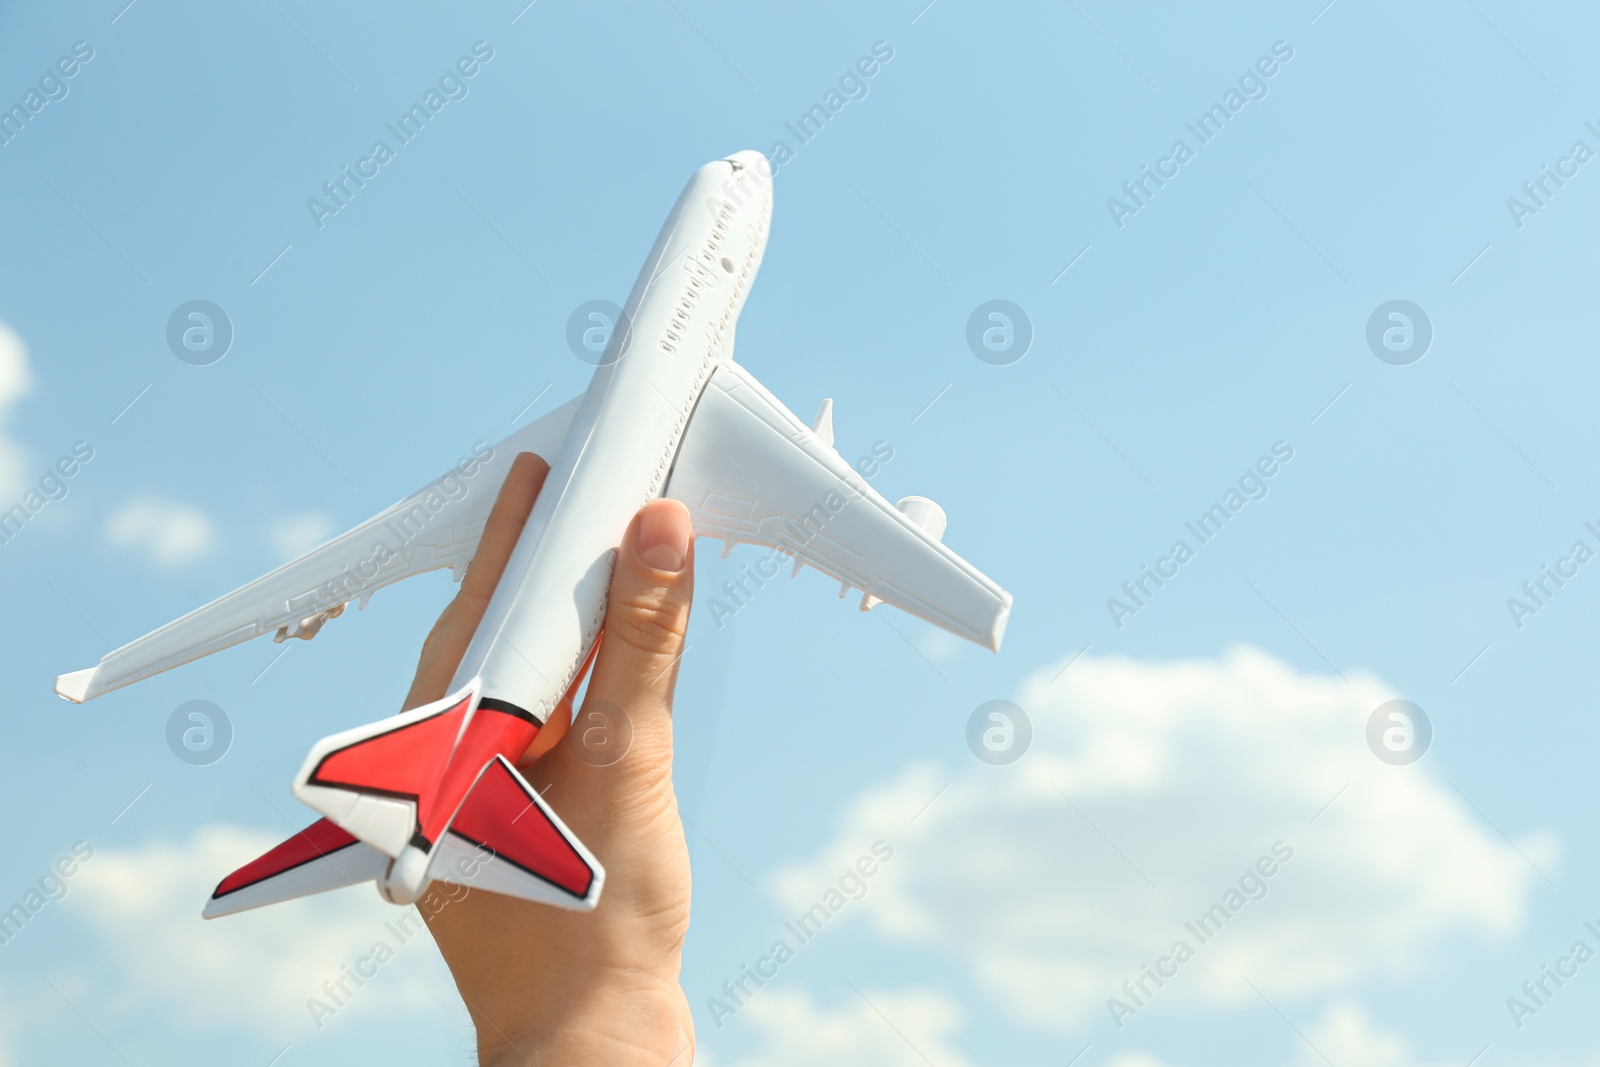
[405,453,694,1067]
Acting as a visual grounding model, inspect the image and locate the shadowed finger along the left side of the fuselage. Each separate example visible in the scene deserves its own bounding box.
[402,453,550,710]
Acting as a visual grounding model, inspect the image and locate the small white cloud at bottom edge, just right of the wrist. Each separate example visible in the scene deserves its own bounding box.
[710,989,973,1067]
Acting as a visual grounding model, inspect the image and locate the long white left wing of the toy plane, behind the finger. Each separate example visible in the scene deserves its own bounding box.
[56,398,578,704]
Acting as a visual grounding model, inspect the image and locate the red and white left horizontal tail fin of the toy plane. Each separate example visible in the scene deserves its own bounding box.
[200,819,389,918]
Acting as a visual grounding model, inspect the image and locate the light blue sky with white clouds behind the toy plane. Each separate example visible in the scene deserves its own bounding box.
[0,0,1600,1067]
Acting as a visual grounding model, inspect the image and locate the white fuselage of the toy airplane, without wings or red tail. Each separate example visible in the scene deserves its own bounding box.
[450,152,773,723]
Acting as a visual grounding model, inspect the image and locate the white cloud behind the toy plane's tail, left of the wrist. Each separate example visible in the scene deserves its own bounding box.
[58,825,454,1040]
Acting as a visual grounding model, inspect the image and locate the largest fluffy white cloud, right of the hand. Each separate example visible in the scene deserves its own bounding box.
[778,648,1557,1030]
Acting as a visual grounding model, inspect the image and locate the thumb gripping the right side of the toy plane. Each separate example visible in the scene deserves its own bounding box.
[582,499,694,758]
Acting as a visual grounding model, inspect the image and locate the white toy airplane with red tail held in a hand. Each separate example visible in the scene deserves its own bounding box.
[56,152,1011,918]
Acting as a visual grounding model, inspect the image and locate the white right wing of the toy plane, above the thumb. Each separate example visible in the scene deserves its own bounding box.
[666,363,1011,651]
